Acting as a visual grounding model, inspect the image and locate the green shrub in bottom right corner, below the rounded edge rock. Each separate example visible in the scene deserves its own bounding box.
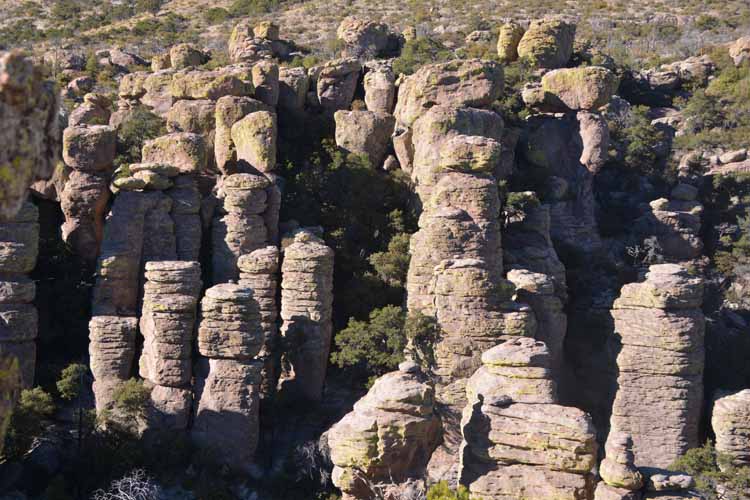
[669,441,750,500]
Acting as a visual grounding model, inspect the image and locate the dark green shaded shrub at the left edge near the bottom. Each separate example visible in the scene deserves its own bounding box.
[4,387,55,460]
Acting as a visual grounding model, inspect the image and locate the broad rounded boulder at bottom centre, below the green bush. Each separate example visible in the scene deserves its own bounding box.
[326,362,440,500]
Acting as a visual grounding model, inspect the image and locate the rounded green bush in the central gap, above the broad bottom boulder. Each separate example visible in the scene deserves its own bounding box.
[331,306,406,379]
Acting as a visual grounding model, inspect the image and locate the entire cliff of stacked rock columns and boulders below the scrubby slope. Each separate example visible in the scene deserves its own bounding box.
[0,11,750,500]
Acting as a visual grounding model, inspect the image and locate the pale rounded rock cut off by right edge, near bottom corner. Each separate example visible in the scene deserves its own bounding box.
[711,389,750,467]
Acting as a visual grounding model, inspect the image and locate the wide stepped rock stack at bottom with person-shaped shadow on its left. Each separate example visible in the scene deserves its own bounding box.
[460,338,597,500]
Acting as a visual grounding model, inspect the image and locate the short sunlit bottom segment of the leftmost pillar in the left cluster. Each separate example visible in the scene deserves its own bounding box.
[89,316,138,413]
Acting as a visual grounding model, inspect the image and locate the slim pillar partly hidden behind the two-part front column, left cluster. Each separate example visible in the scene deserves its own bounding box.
[237,246,279,398]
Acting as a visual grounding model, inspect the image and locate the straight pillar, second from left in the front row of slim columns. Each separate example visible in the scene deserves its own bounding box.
[139,261,201,429]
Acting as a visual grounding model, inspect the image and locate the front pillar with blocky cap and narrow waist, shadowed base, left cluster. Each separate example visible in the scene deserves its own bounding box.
[191,283,264,472]
